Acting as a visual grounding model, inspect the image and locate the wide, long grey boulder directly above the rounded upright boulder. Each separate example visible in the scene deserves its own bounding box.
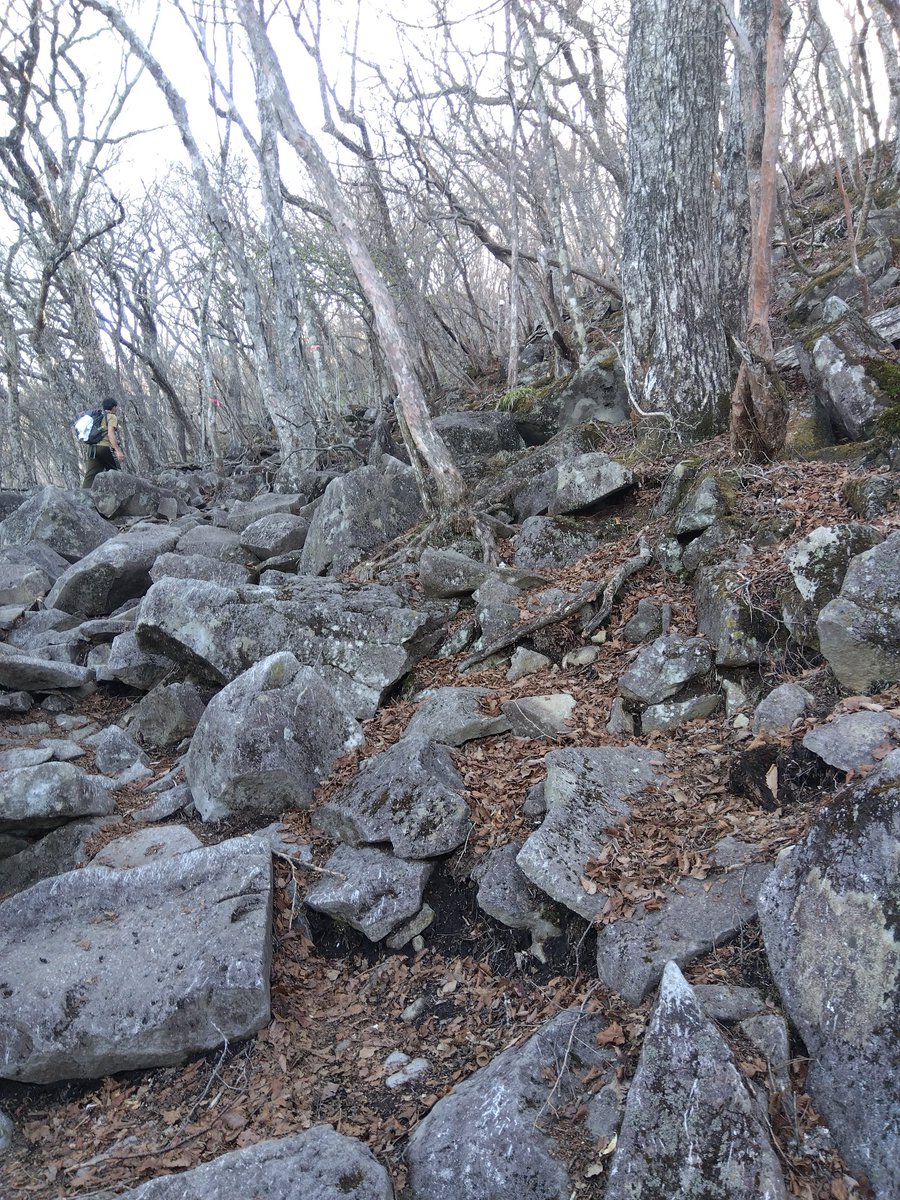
[136,578,443,716]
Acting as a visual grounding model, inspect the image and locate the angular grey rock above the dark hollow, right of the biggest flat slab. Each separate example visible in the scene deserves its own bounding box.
[304,846,433,942]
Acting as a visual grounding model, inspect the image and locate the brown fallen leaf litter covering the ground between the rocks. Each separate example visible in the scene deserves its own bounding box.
[0,442,900,1200]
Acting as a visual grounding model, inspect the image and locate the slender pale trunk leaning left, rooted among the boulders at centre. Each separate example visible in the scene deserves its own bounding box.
[238,0,466,514]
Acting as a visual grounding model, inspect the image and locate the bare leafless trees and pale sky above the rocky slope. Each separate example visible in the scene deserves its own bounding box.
[0,0,900,492]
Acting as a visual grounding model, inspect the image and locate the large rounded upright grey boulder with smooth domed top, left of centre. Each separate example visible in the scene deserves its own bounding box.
[185,652,364,821]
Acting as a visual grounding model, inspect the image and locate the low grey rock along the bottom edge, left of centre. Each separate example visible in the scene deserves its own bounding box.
[114,1126,394,1200]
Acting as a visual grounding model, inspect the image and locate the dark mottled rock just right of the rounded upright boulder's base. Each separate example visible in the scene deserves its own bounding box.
[314,738,472,858]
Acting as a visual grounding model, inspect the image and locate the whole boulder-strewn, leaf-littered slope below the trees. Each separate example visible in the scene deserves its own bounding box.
[0,413,900,1200]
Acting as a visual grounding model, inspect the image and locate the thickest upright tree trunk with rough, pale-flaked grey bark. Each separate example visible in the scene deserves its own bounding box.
[622,0,730,442]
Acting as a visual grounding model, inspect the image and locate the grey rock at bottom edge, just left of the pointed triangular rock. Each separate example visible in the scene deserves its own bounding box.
[407,1010,612,1200]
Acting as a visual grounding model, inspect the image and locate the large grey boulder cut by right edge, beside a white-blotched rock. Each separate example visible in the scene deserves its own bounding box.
[816,533,900,692]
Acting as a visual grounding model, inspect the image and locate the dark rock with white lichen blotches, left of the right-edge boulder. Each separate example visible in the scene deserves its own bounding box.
[781,523,883,649]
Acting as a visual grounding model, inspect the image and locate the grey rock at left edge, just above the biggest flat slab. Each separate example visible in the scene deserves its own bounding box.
[0,762,114,832]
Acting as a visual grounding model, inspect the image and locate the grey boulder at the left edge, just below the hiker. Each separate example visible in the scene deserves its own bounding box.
[0,487,116,563]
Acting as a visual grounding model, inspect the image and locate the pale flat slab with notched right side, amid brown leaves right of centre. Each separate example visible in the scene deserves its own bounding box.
[517,746,667,920]
